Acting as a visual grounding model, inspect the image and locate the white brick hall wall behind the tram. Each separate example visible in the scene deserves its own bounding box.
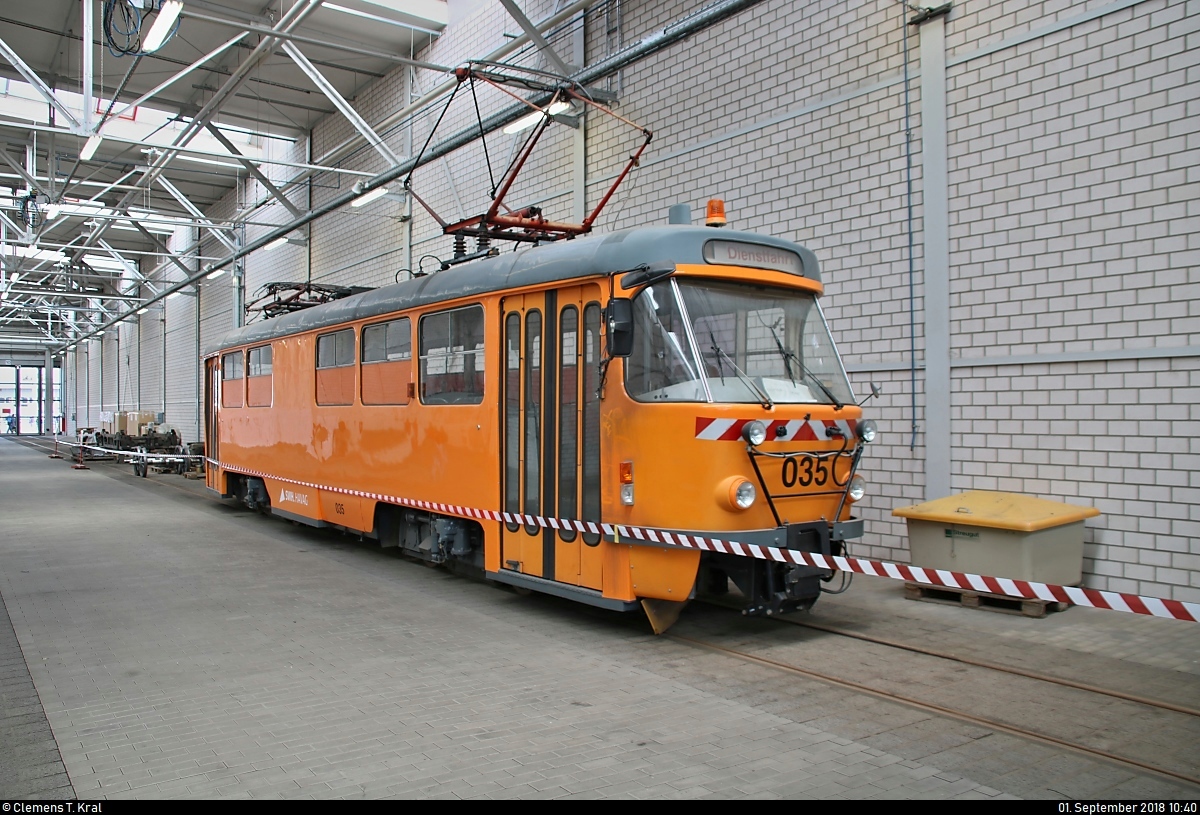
[108,0,1200,601]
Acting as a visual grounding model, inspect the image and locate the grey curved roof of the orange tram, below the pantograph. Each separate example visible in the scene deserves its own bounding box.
[204,226,821,355]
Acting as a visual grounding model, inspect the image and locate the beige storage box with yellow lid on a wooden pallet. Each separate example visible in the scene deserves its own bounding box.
[892,490,1100,586]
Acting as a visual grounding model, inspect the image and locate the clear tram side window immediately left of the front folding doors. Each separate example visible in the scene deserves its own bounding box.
[420,306,484,404]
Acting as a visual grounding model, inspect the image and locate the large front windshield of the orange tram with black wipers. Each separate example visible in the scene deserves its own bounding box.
[625,277,854,407]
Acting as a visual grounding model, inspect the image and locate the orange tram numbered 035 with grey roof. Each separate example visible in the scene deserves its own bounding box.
[204,218,875,630]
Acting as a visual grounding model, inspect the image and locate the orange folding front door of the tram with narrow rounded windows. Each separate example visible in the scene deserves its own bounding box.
[500,283,602,589]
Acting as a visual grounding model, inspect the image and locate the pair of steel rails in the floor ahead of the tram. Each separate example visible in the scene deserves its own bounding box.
[664,619,1200,789]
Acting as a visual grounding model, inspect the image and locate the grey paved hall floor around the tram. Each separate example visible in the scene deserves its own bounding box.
[0,439,1200,799]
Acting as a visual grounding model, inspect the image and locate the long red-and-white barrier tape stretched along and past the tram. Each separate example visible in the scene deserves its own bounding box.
[208,459,1200,623]
